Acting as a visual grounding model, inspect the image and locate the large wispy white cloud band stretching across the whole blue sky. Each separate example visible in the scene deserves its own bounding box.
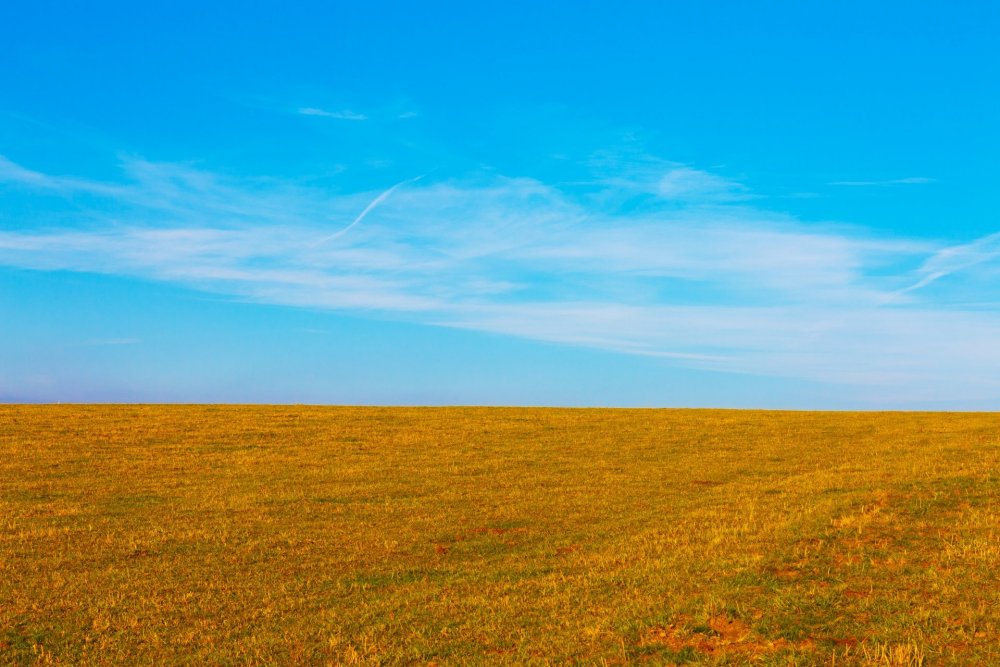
[0,154,1000,399]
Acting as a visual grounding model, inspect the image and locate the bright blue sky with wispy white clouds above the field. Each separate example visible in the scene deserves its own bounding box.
[0,0,1000,410]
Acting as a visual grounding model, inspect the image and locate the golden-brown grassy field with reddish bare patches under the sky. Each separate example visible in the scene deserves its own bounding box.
[0,406,1000,665]
